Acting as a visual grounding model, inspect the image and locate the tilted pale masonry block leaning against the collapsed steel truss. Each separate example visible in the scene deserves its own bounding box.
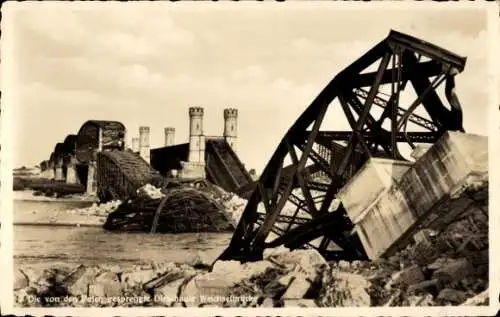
[339,132,488,260]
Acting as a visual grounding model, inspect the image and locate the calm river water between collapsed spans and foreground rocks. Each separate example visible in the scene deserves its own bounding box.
[13,202,232,265]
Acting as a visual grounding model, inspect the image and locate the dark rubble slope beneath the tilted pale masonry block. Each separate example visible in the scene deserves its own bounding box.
[324,210,488,306]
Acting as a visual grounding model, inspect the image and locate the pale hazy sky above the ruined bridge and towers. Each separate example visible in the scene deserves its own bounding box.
[3,2,496,172]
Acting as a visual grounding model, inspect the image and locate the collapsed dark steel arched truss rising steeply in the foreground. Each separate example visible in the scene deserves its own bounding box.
[219,31,466,261]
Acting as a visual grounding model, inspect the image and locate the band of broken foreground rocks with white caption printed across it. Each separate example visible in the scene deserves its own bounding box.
[14,239,488,307]
